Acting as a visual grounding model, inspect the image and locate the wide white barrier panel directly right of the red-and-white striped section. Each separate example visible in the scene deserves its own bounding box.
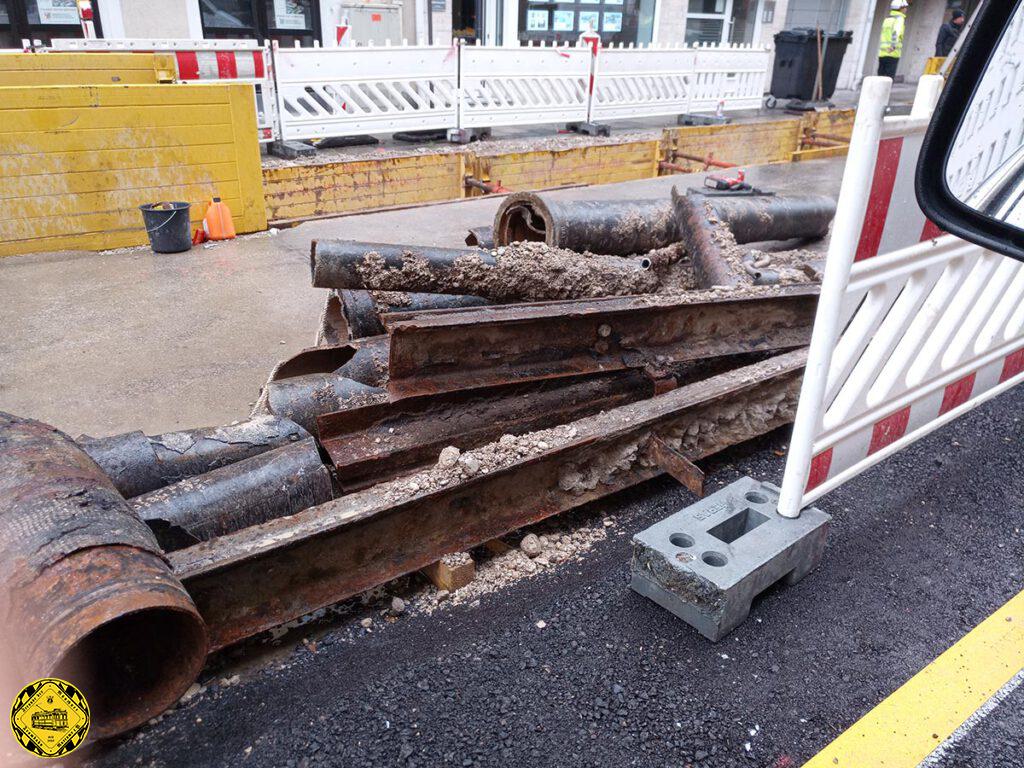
[273,45,459,139]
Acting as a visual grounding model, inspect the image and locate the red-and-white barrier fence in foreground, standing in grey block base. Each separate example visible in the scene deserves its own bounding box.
[778,76,1024,517]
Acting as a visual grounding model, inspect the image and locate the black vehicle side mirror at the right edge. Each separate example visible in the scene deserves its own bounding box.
[915,0,1024,261]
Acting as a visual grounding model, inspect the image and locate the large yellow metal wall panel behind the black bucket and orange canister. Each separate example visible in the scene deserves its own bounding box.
[0,83,266,256]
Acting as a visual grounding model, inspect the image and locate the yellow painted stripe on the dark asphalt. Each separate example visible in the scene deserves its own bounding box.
[805,592,1024,768]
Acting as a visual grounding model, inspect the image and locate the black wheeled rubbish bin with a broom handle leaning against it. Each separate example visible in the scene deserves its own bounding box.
[769,28,853,106]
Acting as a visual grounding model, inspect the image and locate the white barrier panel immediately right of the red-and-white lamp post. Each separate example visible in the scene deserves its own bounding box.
[590,46,697,123]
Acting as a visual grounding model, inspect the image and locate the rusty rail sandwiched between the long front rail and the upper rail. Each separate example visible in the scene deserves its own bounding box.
[317,371,654,490]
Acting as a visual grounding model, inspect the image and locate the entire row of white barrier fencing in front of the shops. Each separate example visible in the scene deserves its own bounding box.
[46,39,769,140]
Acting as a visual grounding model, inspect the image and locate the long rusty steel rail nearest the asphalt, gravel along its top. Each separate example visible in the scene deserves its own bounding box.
[169,349,806,649]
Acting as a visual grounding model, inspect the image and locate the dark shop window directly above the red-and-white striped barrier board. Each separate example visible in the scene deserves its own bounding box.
[199,0,319,46]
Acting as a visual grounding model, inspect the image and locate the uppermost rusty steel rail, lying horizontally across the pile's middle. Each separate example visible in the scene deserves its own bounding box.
[384,285,818,399]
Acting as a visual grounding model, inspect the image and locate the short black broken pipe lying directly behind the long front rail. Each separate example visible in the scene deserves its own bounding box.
[131,437,334,552]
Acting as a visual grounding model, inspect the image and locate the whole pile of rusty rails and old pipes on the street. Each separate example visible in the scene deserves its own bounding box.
[0,183,830,735]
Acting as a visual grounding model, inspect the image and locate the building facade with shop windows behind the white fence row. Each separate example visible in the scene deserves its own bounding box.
[0,0,966,88]
